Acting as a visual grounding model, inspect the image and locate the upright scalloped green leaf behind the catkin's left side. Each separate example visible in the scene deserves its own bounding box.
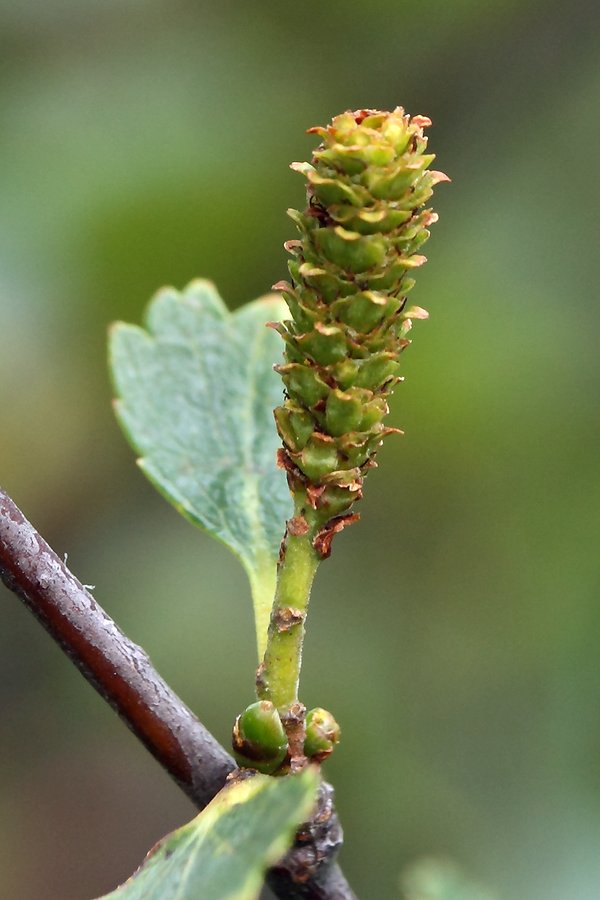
[110,280,291,656]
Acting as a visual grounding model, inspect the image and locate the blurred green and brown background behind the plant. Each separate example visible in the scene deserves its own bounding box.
[0,0,600,900]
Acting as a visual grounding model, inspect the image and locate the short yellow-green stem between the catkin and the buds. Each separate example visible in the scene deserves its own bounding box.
[256,497,321,719]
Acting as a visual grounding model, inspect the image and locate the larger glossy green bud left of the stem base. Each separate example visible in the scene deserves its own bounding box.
[232,700,288,775]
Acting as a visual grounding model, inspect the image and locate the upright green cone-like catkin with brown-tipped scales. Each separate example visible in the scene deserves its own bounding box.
[274,107,449,557]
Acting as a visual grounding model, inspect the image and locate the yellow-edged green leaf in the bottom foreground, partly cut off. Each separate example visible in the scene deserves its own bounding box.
[99,768,318,900]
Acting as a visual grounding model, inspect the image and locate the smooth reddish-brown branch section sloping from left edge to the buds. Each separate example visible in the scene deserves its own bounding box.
[0,490,235,808]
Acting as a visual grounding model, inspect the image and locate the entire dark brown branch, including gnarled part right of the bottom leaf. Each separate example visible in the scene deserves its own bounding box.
[0,489,354,900]
